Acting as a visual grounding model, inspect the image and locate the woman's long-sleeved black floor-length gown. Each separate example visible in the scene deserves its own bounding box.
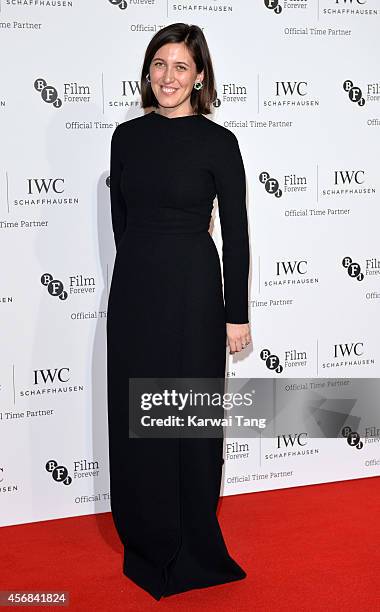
[107,111,249,600]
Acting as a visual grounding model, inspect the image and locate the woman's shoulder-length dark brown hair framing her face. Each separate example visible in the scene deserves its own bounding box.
[140,23,216,115]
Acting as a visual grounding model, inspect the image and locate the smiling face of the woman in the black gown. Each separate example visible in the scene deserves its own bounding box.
[149,42,203,113]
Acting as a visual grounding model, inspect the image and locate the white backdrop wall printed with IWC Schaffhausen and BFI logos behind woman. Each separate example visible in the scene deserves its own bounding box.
[0,0,380,525]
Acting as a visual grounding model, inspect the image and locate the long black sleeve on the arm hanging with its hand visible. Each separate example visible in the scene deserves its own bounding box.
[214,131,249,323]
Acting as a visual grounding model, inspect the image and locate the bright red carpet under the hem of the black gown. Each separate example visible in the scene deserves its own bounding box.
[0,477,380,612]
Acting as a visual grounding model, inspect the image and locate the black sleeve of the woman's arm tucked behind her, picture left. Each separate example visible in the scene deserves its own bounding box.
[110,125,127,249]
